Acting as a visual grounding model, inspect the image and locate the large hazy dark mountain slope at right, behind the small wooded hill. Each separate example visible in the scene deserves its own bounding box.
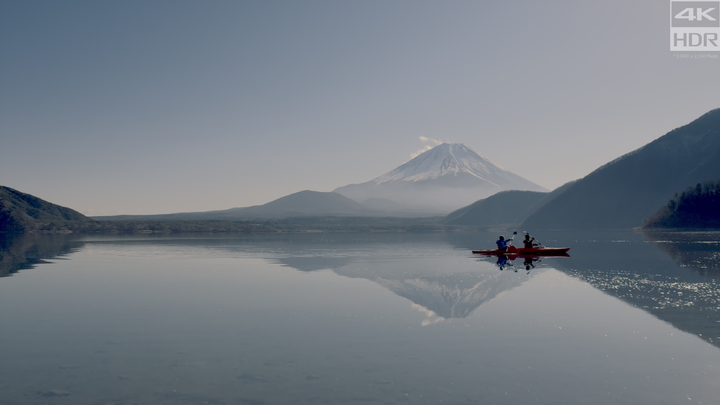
[522,109,720,229]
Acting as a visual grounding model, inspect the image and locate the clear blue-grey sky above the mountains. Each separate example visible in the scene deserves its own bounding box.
[0,0,720,215]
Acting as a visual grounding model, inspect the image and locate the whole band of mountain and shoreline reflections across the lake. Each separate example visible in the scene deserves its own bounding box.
[0,231,720,347]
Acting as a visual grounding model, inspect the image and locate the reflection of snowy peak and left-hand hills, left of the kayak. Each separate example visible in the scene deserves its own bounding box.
[2,236,532,319]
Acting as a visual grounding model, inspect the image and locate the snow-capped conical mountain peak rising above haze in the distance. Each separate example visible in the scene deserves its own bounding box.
[335,143,547,212]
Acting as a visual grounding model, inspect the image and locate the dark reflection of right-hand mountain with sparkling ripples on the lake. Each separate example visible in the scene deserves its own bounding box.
[524,232,720,347]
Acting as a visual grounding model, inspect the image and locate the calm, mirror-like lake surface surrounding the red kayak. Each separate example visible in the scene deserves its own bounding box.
[0,231,720,405]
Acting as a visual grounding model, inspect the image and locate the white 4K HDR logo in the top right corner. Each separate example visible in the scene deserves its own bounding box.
[670,0,720,52]
